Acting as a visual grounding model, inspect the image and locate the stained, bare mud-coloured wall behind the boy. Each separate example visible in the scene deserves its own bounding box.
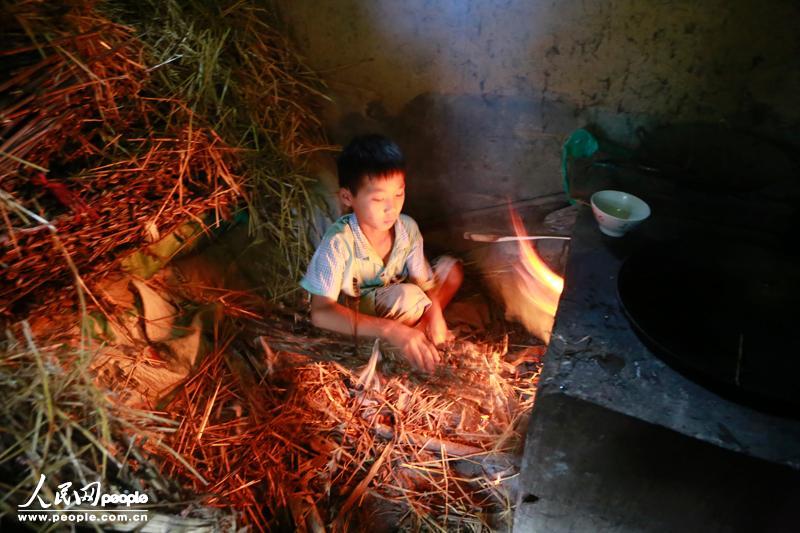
[280,0,800,243]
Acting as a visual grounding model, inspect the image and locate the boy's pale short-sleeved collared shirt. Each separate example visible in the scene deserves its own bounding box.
[300,213,435,300]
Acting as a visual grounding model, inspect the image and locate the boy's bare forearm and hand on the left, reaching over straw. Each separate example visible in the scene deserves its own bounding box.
[311,294,439,372]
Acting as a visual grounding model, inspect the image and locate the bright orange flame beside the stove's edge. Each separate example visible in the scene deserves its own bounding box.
[510,209,564,342]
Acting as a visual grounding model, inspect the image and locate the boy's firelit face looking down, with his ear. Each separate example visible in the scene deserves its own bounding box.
[341,172,406,232]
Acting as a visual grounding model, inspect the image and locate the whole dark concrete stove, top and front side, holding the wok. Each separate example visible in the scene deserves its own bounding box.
[514,204,800,532]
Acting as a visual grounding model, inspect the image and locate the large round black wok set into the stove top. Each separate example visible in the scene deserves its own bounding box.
[617,237,800,416]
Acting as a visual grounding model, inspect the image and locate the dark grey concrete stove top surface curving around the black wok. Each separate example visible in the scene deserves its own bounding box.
[538,208,800,469]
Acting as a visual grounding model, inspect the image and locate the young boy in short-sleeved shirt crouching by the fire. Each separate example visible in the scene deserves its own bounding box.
[300,135,463,372]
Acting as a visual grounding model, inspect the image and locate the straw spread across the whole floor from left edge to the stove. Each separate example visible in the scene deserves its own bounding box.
[0,274,543,531]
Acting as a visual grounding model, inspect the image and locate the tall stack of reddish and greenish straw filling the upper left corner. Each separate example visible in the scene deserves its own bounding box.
[0,1,330,319]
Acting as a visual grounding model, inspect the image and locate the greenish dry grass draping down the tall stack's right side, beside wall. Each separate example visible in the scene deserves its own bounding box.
[104,0,336,298]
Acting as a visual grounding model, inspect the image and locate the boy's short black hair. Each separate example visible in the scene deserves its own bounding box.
[336,134,406,195]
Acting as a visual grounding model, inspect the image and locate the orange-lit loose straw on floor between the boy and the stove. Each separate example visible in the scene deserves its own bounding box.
[145,302,541,531]
